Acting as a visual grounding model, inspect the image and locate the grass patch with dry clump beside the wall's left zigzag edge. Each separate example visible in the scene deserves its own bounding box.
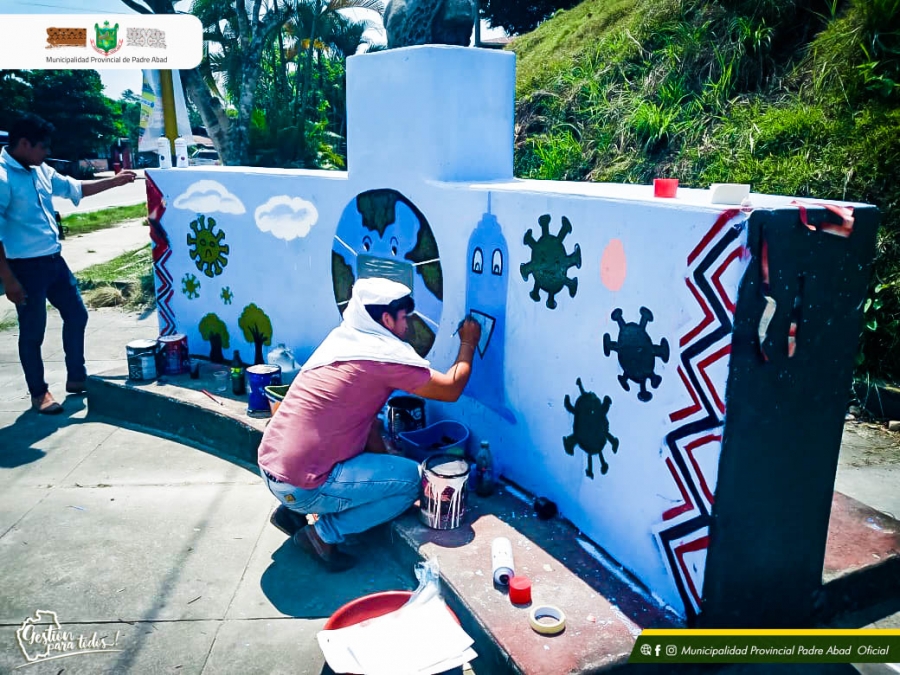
[75,245,156,310]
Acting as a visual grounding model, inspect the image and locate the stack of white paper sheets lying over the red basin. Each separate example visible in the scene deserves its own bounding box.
[316,596,478,675]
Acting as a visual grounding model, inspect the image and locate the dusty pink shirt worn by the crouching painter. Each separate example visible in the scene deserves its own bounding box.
[259,361,431,489]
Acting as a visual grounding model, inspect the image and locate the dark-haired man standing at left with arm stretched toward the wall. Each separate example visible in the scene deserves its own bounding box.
[0,114,135,415]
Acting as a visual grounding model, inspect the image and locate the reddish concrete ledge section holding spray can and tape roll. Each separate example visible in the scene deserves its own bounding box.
[393,487,681,675]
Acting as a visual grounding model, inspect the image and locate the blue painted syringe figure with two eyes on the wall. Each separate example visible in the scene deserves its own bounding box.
[465,197,516,423]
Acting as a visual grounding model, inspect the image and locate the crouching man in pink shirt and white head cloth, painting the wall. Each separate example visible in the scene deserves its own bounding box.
[259,279,481,572]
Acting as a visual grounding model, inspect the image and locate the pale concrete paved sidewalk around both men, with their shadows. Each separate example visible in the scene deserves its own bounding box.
[0,310,414,675]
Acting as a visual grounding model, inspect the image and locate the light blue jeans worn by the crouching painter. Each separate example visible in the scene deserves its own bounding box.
[260,452,421,544]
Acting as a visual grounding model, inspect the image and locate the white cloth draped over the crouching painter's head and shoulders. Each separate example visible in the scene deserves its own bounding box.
[302,278,431,370]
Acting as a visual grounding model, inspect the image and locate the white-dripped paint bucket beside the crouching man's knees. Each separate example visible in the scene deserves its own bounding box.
[419,454,469,530]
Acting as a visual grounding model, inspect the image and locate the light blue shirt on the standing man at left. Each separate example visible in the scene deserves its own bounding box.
[0,148,82,258]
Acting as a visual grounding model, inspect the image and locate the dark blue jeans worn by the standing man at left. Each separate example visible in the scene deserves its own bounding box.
[8,253,88,396]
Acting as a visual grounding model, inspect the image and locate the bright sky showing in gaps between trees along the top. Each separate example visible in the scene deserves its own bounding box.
[0,0,504,99]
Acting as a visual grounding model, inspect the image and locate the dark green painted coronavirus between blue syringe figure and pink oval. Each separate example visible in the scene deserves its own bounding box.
[519,214,581,309]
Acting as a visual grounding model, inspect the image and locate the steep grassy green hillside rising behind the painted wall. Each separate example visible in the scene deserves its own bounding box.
[510,0,900,381]
